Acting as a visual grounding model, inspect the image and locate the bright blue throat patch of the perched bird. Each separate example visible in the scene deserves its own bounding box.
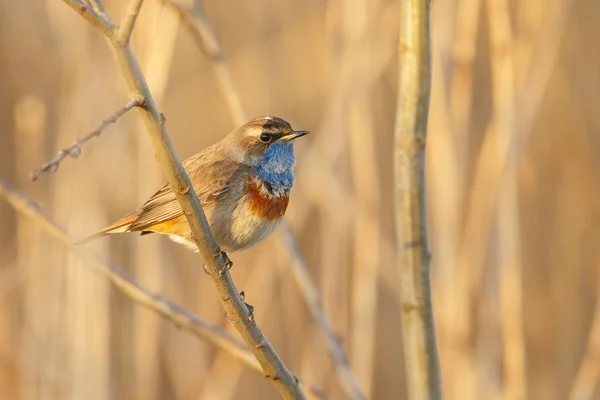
[253,142,296,194]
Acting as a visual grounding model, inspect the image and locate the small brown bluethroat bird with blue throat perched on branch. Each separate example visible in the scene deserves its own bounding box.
[78,116,308,252]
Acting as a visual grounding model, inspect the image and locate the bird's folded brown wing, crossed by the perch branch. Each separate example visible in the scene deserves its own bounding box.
[125,155,248,231]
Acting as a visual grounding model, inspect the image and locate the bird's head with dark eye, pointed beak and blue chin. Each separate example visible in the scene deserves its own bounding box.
[226,116,308,172]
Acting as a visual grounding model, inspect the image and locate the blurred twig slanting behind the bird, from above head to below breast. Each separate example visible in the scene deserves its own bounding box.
[163,0,364,400]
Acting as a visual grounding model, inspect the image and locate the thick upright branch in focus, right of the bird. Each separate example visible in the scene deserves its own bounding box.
[394,0,442,399]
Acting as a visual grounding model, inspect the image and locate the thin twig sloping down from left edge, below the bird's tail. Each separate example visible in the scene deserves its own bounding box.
[0,178,327,399]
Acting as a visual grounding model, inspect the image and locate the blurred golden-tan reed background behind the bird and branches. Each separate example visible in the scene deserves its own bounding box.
[0,0,600,400]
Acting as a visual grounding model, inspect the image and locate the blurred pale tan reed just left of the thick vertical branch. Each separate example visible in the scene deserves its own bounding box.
[341,0,381,398]
